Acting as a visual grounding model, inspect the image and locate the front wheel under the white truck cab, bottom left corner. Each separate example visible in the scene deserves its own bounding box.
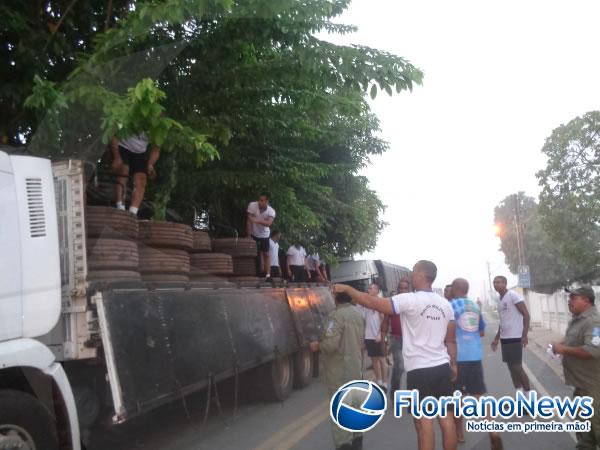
[0,390,58,450]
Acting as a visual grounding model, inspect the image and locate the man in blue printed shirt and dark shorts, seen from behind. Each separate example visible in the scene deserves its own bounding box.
[450,278,503,450]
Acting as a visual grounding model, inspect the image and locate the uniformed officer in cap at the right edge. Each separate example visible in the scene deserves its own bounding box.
[552,286,600,450]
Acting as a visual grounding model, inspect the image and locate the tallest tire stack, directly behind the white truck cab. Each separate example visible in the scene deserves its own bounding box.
[85,206,140,281]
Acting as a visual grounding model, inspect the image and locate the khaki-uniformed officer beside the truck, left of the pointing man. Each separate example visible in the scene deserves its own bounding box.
[310,293,365,450]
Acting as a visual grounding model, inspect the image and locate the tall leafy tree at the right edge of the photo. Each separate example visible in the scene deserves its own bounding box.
[537,111,600,281]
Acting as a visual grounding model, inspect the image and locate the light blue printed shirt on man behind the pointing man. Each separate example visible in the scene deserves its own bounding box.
[450,298,485,362]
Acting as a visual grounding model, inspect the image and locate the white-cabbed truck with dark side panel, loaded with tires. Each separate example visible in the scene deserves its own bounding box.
[0,151,335,444]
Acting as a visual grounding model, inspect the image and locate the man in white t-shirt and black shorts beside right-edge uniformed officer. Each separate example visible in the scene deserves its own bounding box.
[492,275,531,393]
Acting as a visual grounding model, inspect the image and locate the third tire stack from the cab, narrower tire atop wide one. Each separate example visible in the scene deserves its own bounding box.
[190,231,233,281]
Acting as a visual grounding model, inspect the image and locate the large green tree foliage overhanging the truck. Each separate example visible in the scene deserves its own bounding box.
[0,0,422,255]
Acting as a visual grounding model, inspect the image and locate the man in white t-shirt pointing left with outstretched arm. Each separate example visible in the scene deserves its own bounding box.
[334,260,456,450]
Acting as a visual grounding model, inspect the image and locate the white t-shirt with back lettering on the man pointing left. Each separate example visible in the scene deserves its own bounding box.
[391,291,454,372]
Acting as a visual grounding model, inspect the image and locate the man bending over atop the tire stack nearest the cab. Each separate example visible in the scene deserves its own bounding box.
[110,133,160,215]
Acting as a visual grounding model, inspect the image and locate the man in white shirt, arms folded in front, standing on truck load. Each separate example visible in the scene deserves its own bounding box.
[246,193,275,281]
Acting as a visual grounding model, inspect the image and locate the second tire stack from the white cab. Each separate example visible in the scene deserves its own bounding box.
[138,220,193,282]
